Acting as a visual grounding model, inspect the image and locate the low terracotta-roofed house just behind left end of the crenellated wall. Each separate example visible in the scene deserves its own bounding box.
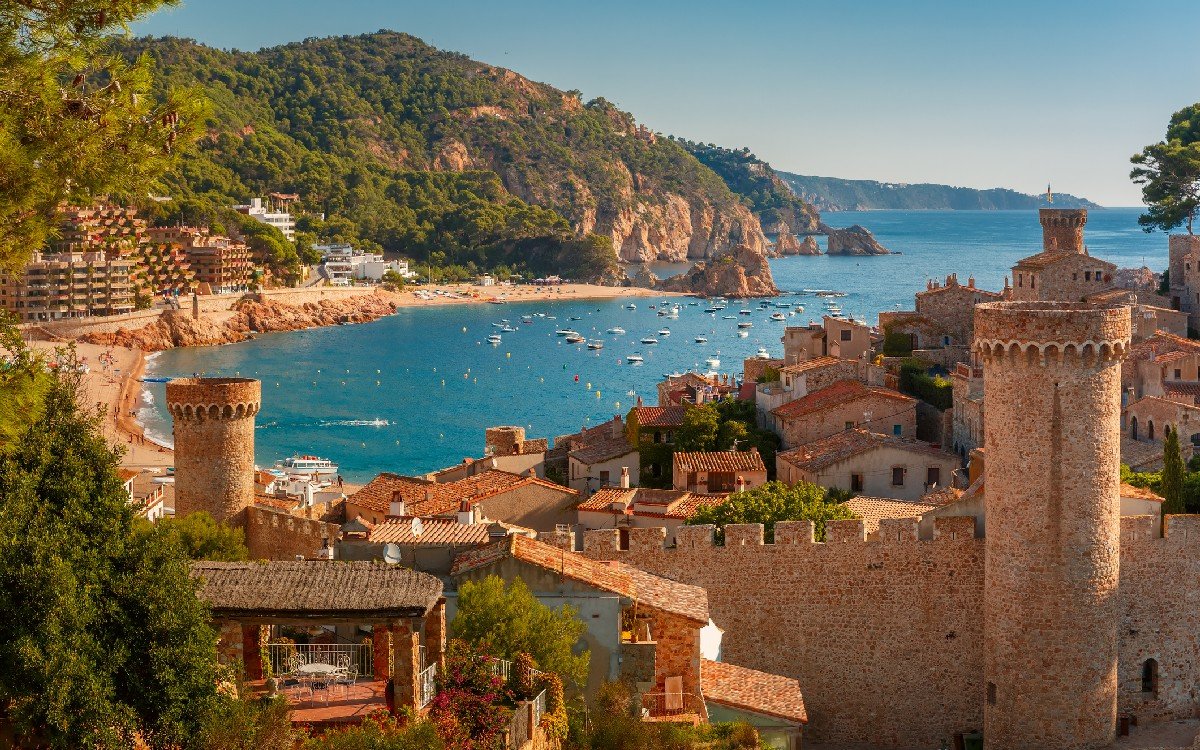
[576,487,728,544]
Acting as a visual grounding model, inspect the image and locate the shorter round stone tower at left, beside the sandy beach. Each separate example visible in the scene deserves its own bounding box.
[167,378,263,521]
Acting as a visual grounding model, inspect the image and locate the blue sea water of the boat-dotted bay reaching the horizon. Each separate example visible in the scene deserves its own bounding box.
[138,209,1168,482]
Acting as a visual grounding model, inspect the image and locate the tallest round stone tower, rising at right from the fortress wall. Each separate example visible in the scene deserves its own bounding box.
[974,301,1130,750]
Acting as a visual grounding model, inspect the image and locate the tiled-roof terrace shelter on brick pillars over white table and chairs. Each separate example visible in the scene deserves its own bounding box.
[192,560,445,710]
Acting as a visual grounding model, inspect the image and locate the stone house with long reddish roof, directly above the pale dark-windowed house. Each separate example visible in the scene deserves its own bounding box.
[772,380,917,448]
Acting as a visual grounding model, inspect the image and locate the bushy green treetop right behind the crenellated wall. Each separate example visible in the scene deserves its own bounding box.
[688,481,854,544]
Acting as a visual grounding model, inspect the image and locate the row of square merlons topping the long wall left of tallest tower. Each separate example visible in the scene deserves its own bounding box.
[583,516,982,557]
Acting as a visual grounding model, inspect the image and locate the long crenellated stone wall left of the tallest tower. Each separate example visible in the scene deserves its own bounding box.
[584,518,983,748]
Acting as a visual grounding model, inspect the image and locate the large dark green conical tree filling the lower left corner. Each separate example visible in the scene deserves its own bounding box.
[0,319,217,749]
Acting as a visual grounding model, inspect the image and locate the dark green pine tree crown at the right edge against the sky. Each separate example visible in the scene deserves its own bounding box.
[1129,102,1200,234]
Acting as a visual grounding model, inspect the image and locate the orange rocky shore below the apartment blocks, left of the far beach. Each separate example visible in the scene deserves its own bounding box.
[80,294,396,352]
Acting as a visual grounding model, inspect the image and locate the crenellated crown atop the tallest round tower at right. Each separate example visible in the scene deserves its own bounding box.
[974,301,1130,367]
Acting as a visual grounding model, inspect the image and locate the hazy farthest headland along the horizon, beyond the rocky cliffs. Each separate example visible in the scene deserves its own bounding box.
[779,172,1104,212]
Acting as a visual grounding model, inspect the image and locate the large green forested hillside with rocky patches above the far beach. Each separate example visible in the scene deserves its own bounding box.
[110,31,758,280]
